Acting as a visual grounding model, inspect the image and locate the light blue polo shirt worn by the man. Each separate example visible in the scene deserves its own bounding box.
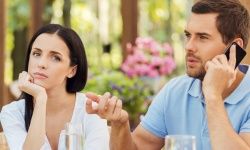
[141,66,250,150]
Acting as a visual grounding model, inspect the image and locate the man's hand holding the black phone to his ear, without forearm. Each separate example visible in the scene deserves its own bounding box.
[202,43,240,99]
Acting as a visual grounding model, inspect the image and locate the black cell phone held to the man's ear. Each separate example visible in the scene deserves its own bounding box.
[225,42,247,69]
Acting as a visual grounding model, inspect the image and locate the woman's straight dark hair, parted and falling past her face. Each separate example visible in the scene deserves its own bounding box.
[19,24,88,131]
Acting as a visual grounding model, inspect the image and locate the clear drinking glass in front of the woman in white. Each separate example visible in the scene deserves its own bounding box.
[64,123,84,150]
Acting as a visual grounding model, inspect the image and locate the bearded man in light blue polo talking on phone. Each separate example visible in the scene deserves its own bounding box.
[86,0,250,150]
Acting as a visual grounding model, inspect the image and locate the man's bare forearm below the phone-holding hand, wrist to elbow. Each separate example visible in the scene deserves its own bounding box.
[206,99,250,150]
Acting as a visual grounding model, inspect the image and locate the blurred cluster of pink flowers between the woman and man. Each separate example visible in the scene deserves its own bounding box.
[121,37,176,77]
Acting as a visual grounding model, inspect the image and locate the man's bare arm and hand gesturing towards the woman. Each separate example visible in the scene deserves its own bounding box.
[86,93,164,150]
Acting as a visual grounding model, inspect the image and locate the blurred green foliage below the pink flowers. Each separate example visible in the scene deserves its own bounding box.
[84,71,151,120]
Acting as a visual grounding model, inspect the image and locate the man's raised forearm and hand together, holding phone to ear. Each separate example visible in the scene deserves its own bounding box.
[202,46,250,150]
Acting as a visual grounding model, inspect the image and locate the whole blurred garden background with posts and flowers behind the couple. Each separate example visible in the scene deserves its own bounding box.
[0,0,250,127]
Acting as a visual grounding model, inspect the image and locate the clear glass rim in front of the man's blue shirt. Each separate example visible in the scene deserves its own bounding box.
[165,135,196,150]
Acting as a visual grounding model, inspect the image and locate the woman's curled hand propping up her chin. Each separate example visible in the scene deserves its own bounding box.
[18,71,47,100]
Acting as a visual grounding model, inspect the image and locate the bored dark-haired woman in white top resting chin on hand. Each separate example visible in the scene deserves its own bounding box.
[1,24,109,150]
